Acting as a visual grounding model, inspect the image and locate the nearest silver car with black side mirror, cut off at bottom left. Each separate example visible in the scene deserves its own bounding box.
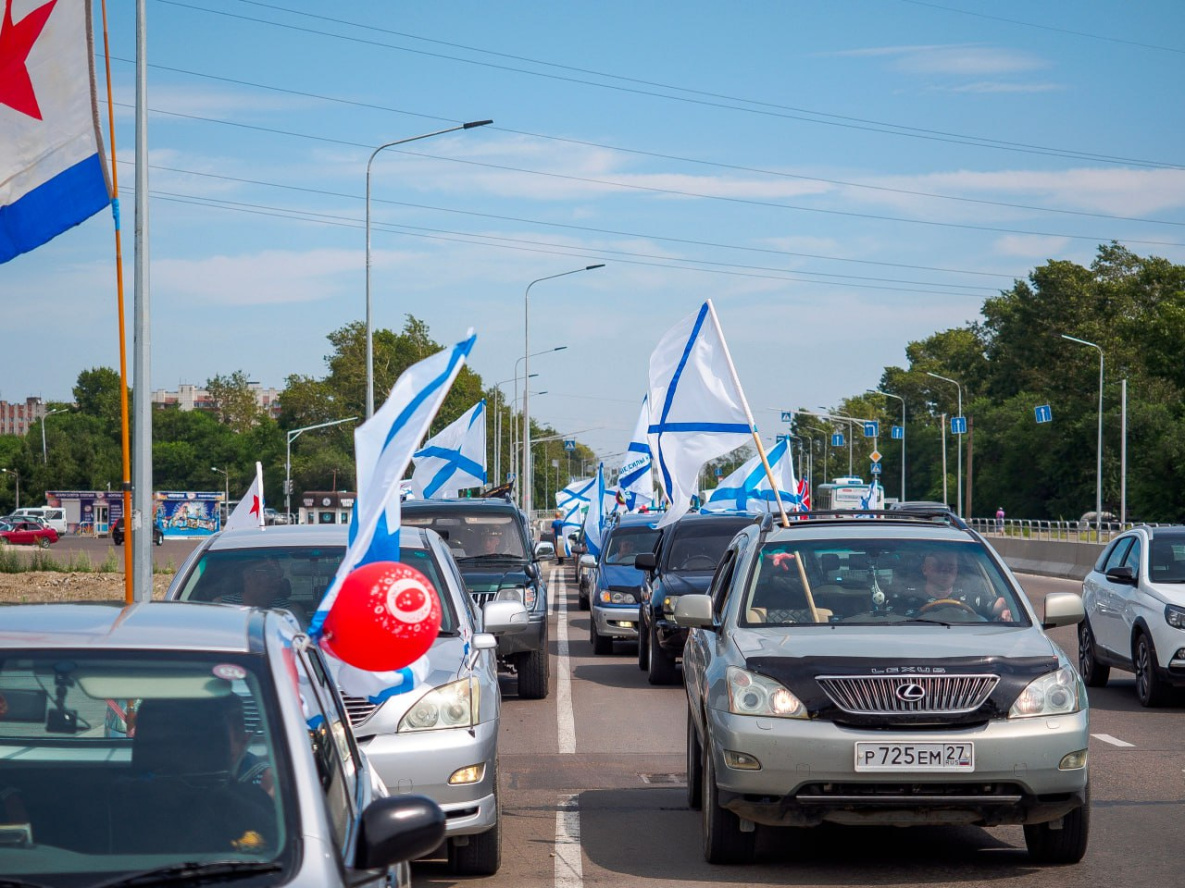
[0,602,444,888]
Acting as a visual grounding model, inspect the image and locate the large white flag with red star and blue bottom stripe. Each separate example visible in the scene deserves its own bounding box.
[0,0,111,262]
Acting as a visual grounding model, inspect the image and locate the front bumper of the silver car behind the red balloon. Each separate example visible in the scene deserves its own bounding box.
[359,721,498,836]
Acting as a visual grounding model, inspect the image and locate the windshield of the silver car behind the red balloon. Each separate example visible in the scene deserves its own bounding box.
[178,545,457,634]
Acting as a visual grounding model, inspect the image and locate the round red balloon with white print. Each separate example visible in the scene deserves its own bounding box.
[322,561,441,672]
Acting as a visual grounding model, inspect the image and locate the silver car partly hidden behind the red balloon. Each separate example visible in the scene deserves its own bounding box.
[166,525,527,875]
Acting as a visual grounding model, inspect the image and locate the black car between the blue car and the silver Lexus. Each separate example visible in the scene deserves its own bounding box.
[634,512,756,684]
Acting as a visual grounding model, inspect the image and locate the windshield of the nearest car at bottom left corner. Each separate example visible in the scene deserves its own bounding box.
[0,651,289,886]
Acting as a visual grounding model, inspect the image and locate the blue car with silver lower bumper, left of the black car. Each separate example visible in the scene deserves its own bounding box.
[589,515,659,654]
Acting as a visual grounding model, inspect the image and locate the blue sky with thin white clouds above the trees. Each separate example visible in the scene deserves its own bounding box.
[0,0,1185,454]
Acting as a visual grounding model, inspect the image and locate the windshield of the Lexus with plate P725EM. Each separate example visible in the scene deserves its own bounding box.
[738,539,1029,628]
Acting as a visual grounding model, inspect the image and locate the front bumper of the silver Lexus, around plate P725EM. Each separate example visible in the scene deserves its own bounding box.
[709,710,1088,826]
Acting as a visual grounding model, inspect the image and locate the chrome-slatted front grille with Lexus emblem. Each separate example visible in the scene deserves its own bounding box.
[816,673,1000,715]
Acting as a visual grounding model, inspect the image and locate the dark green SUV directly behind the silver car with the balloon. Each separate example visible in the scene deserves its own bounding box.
[402,498,549,699]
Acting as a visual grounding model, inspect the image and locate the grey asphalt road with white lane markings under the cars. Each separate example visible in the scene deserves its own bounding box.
[414,564,1185,888]
